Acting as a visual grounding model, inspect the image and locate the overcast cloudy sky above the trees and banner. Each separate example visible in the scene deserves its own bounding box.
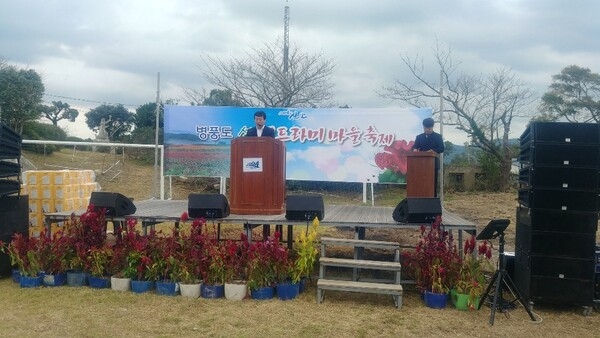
[0,0,600,143]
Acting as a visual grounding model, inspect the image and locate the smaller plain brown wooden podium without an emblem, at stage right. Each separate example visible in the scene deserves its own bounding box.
[406,151,437,197]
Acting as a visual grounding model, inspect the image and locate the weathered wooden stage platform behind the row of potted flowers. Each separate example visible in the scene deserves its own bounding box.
[44,200,476,247]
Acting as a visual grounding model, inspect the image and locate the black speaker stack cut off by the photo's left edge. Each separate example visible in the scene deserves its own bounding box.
[0,123,29,275]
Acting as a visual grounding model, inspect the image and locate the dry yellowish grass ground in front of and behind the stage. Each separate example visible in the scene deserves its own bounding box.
[0,150,600,337]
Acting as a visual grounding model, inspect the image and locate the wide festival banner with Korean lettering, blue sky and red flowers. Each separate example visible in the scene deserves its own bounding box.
[164,105,432,183]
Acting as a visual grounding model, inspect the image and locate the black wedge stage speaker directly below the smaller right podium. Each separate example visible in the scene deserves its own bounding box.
[392,197,442,223]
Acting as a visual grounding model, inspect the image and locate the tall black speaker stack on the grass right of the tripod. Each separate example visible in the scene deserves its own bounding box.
[514,122,600,306]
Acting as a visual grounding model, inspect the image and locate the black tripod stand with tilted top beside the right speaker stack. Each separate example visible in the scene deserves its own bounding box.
[477,220,535,325]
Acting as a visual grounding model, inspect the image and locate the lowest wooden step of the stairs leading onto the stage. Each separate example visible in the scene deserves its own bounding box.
[317,279,403,309]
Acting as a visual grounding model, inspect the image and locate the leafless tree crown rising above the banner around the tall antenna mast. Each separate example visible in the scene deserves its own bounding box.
[198,42,335,107]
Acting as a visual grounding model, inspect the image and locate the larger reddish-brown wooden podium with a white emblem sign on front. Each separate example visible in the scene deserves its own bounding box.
[229,137,285,215]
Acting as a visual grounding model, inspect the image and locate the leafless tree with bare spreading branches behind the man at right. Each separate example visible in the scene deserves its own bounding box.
[379,45,535,190]
